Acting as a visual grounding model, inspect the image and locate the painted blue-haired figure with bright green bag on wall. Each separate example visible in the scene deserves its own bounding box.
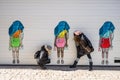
[8,20,24,64]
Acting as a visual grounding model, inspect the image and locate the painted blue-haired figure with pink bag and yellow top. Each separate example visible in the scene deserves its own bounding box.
[54,21,70,64]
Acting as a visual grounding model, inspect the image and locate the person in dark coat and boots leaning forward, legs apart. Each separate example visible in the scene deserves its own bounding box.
[70,30,94,71]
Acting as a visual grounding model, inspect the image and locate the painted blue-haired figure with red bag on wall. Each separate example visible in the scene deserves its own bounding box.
[98,21,115,64]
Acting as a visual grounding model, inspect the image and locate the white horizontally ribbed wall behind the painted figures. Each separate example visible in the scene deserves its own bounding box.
[0,0,120,65]
